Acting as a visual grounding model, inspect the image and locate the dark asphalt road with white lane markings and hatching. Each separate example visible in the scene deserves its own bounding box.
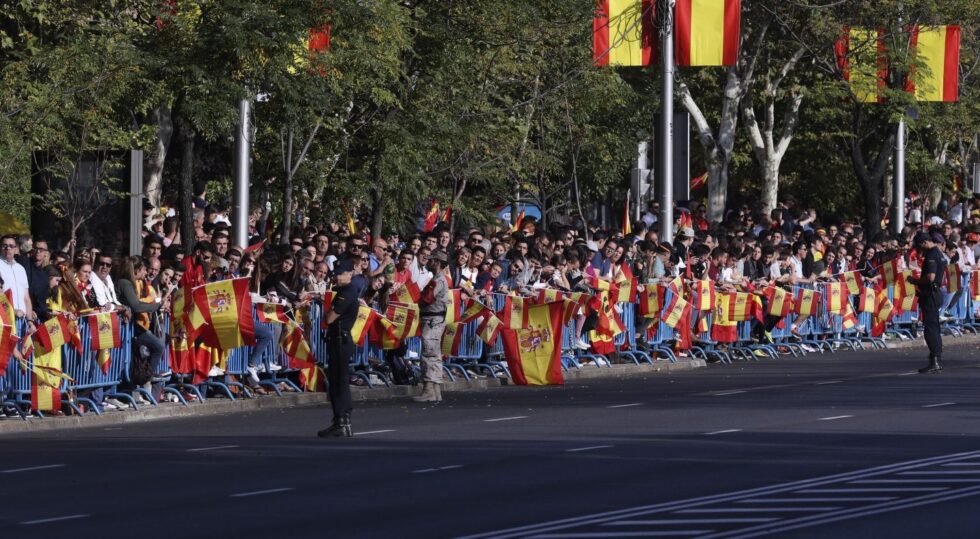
[0,345,980,539]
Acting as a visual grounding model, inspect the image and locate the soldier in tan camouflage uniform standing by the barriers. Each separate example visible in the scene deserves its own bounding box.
[412,251,449,402]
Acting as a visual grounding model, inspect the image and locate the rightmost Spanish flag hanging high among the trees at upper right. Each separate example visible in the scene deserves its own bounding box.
[906,26,960,103]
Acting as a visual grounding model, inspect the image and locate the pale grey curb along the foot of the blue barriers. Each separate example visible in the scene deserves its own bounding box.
[0,359,706,436]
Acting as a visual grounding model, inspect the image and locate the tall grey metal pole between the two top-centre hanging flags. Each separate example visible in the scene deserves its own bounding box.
[657,0,674,242]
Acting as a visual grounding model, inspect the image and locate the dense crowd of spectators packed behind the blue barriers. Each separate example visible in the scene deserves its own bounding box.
[0,189,980,418]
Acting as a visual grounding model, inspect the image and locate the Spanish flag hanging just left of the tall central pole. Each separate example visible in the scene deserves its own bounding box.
[592,0,657,66]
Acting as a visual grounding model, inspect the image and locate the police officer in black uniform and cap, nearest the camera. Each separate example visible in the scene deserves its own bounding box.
[317,259,360,438]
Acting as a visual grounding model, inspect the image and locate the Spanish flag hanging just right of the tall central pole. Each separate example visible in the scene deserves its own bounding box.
[674,0,742,66]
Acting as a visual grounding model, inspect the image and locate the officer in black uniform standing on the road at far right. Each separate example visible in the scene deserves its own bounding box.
[909,232,946,374]
